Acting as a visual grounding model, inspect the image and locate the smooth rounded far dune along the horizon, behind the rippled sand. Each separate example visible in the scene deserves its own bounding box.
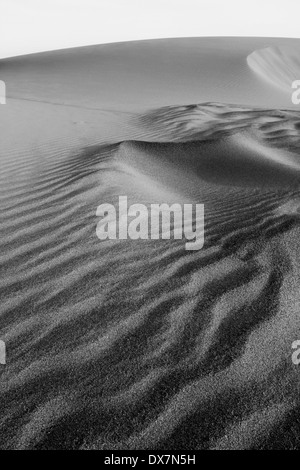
[0,38,300,112]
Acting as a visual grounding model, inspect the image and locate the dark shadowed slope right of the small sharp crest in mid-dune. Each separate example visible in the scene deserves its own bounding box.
[122,135,300,190]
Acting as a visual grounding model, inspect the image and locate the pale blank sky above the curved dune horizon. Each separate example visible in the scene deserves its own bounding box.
[0,0,300,58]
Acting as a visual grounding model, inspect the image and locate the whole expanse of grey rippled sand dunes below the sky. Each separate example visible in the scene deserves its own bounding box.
[0,39,300,450]
